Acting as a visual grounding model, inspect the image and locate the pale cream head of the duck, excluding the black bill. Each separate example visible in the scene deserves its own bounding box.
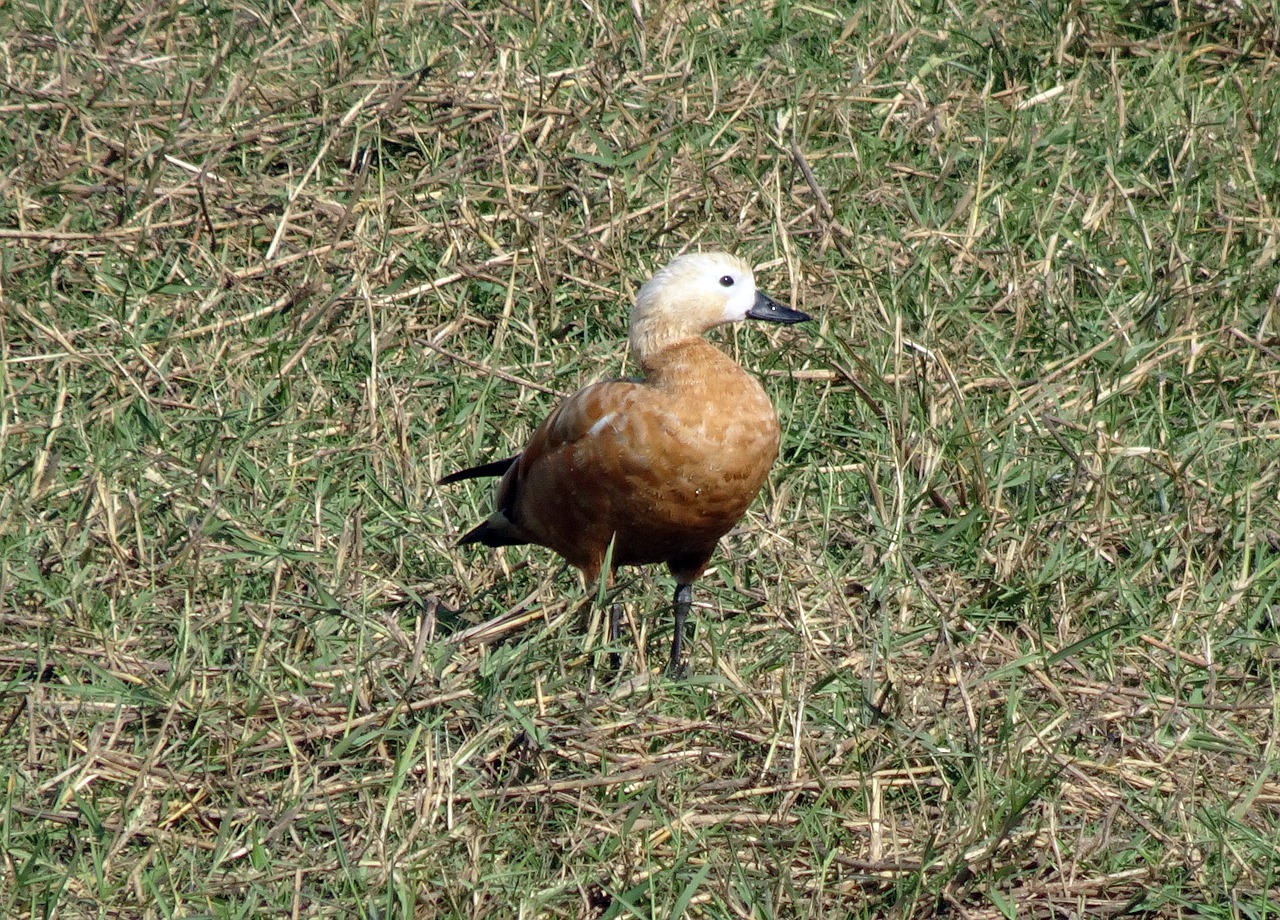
[631,252,755,365]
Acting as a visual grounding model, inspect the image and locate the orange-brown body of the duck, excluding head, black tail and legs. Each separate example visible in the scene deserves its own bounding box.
[499,339,778,582]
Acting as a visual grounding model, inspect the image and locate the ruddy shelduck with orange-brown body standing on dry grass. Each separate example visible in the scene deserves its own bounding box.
[440,253,809,676]
